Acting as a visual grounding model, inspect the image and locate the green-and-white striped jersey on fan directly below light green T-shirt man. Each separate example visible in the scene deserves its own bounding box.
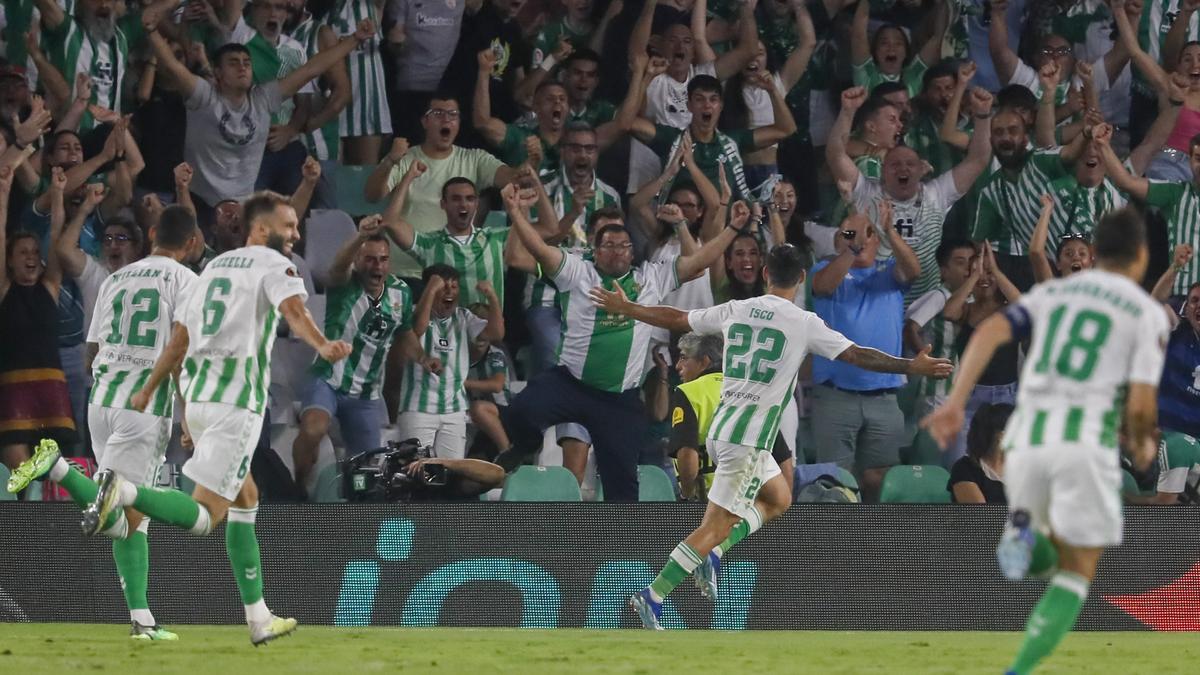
[408,227,512,307]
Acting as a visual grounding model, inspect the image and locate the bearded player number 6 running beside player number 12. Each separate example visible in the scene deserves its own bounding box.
[84,187,350,645]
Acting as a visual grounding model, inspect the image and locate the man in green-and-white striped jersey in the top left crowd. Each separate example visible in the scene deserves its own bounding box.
[35,0,178,131]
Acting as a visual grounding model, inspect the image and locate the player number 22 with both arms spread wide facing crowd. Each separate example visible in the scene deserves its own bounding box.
[590,244,950,629]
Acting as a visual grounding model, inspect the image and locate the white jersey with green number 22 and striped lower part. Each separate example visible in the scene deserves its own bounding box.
[688,295,853,450]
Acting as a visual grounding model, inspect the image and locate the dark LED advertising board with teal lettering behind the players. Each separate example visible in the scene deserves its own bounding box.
[0,502,1200,631]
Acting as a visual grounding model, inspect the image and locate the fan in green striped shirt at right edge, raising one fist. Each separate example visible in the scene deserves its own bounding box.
[1092,124,1200,295]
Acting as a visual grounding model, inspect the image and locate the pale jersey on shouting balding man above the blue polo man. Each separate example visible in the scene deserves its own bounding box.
[851,172,962,305]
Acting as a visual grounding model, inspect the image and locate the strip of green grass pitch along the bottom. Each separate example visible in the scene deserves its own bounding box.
[0,623,1200,675]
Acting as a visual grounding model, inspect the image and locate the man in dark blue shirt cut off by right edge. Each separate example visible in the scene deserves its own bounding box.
[1158,283,1200,437]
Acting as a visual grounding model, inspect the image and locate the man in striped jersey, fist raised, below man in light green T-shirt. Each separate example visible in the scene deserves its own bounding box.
[384,166,525,307]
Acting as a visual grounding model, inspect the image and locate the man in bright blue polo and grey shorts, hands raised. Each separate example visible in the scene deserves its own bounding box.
[812,202,928,501]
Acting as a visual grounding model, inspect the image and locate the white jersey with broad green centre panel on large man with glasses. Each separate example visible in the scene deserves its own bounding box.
[550,253,679,393]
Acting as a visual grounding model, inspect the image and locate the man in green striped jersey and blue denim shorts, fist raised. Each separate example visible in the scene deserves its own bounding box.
[292,216,440,489]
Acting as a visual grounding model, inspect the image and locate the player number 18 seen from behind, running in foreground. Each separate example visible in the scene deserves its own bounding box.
[922,209,1169,674]
